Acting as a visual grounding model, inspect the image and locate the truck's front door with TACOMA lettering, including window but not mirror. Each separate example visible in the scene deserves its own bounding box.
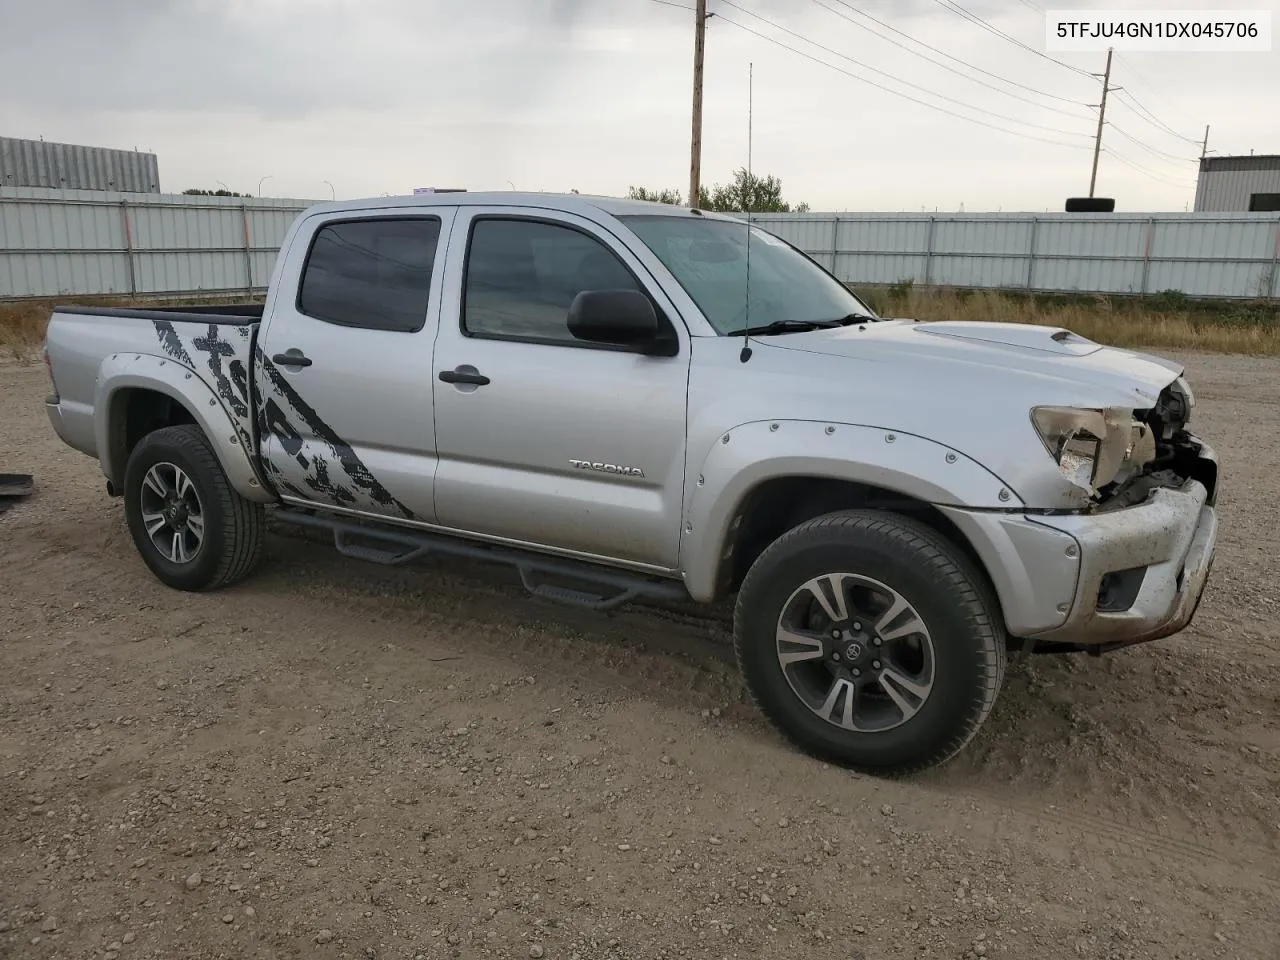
[434,207,689,570]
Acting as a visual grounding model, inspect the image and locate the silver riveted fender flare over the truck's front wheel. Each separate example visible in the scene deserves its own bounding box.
[681,420,1023,602]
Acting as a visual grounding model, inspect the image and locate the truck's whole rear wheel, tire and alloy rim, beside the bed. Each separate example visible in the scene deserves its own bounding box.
[124,424,266,590]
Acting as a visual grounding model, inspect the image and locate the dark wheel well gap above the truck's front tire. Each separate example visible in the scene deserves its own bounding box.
[717,476,995,596]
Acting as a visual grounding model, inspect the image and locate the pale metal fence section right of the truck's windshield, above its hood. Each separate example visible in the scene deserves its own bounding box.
[751,214,1280,298]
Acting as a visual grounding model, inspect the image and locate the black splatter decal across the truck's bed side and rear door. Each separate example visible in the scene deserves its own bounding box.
[154,320,413,520]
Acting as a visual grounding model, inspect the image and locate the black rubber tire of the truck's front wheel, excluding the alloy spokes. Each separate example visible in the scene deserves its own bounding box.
[733,511,1005,774]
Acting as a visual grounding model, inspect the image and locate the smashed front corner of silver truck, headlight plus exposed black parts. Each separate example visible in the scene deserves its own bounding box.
[1032,376,1217,511]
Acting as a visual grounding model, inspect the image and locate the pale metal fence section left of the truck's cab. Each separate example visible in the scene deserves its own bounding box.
[0,188,315,298]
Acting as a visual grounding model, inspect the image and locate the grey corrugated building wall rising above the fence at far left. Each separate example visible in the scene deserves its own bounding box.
[0,137,160,193]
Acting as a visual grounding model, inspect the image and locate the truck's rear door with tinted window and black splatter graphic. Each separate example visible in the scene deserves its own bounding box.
[255,206,454,522]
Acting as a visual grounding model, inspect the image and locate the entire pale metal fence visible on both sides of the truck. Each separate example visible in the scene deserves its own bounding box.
[0,188,1280,298]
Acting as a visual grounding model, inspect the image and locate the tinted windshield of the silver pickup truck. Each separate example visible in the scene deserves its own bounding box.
[621,214,878,337]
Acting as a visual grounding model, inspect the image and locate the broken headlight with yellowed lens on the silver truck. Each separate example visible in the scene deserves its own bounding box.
[1032,407,1156,497]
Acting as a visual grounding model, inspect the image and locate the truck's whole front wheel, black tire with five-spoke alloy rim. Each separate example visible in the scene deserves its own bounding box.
[733,511,1005,773]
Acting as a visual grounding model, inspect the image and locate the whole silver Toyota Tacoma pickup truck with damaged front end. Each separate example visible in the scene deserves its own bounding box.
[46,193,1217,772]
